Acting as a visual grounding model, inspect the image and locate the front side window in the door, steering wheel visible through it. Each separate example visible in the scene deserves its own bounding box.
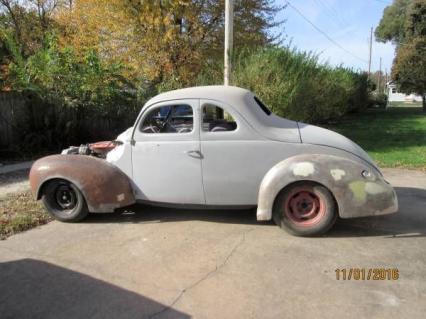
[140,104,194,133]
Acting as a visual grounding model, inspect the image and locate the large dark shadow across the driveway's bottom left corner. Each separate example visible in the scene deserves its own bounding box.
[0,259,190,319]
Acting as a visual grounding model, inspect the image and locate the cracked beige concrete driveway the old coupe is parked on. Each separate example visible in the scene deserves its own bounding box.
[0,169,426,318]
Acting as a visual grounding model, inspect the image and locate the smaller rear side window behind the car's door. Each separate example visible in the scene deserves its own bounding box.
[202,104,237,132]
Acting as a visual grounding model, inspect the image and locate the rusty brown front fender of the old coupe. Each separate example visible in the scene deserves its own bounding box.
[30,155,135,212]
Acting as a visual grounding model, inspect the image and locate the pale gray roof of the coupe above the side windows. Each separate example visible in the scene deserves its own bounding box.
[145,85,253,107]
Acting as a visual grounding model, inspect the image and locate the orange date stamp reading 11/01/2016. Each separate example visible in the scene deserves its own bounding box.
[334,268,399,280]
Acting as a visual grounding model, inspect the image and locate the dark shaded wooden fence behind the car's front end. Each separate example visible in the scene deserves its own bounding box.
[0,92,136,150]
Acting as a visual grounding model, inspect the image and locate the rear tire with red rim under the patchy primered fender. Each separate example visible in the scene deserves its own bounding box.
[272,182,338,236]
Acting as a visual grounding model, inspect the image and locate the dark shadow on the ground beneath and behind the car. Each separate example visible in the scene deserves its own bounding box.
[83,187,426,238]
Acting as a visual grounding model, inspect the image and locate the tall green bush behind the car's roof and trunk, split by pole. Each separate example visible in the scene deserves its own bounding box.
[197,47,368,122]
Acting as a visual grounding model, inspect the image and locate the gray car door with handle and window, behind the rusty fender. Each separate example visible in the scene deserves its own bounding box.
[132,99,205,204]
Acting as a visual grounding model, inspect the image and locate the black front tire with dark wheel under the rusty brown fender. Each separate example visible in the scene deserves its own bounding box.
[41,179,89,223]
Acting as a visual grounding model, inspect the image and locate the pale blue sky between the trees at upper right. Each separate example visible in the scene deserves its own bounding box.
[275,0,394,72]
